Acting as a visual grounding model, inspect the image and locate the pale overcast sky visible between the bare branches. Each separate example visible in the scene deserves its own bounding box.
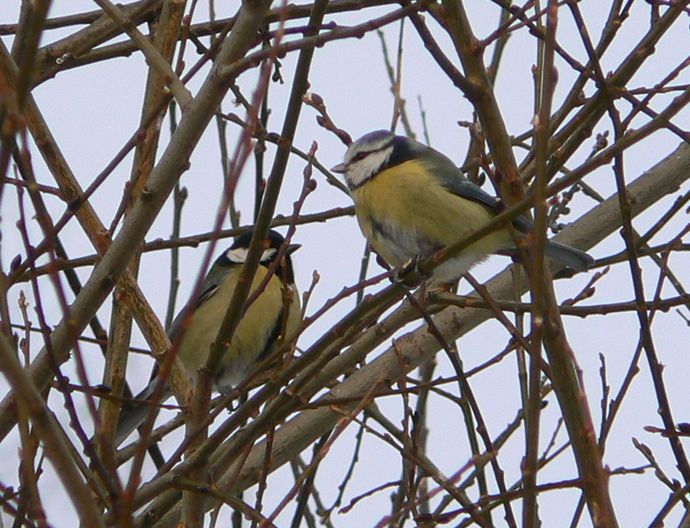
[0,0,690,526]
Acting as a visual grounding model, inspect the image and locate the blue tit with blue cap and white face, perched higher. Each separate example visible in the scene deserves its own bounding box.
[331,130,593,282]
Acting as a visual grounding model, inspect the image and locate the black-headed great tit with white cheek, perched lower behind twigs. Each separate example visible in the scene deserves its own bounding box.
[115,230,301,446]
